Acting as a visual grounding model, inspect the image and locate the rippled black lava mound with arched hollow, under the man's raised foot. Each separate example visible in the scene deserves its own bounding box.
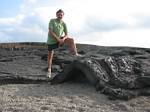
[51,56,150,100]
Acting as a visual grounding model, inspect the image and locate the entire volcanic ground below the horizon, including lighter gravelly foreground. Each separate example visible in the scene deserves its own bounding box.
[0,43,150,112]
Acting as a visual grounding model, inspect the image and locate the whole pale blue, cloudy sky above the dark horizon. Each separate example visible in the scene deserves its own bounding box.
[0,0,150,48]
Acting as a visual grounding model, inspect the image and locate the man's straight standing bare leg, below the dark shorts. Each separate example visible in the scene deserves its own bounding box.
[47,50,54,75]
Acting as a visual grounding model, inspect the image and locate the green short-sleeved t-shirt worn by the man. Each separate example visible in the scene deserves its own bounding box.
[47,19,67,44]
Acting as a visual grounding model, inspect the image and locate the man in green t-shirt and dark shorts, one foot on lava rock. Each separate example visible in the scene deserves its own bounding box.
[47,9,78,78]
